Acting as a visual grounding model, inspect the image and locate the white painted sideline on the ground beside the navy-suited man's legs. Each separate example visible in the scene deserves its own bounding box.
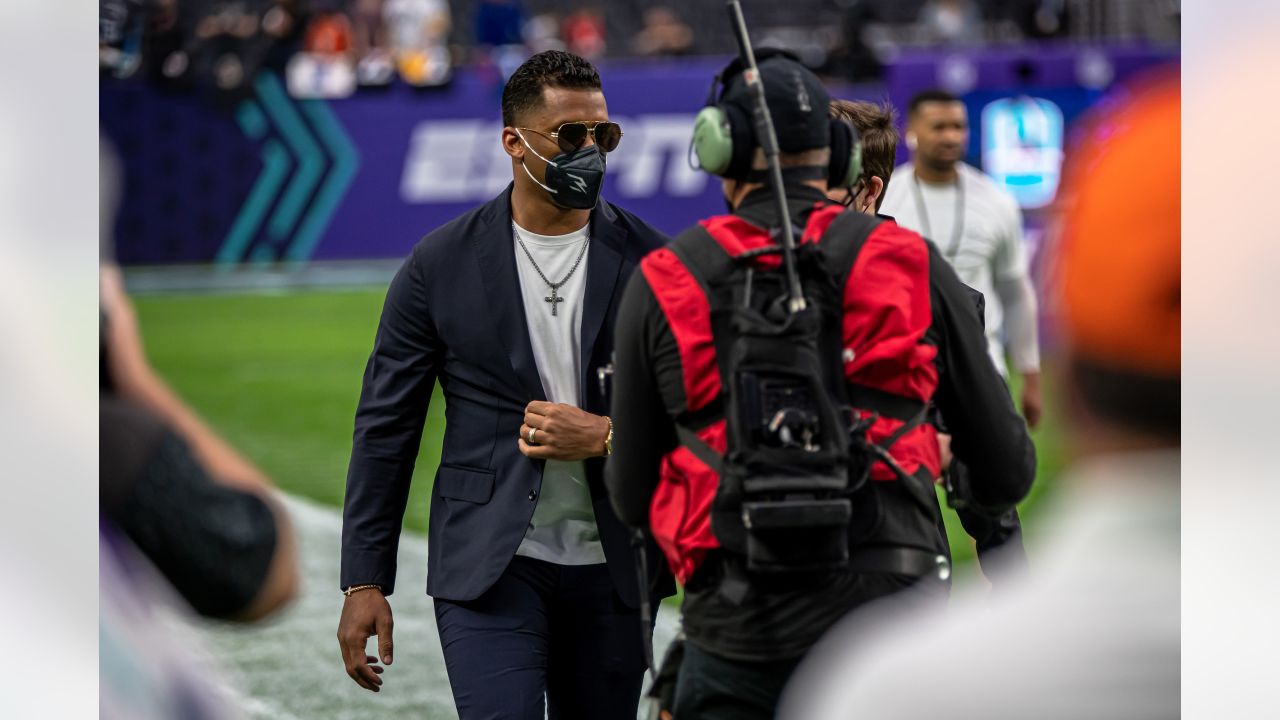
[193,497,676,720]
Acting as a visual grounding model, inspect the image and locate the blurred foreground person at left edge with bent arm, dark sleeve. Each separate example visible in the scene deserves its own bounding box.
[99,135,298,720]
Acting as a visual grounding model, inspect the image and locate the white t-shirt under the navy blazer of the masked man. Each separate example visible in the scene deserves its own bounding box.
[512,217,604,565]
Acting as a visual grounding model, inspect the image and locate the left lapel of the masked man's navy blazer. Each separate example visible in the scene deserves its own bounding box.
[475,186,547,400]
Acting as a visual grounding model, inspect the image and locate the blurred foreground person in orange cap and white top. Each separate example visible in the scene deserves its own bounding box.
[783,76,1181,720]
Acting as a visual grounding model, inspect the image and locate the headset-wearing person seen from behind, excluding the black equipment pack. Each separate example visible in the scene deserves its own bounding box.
[605,50,1036,719]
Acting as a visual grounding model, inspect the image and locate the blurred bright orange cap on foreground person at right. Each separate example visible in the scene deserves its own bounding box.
[1052,74,1181,377]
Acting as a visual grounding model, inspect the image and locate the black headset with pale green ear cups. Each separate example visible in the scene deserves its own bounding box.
[691,49,863,188]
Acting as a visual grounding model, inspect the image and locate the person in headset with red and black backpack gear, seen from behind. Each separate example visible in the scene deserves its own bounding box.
[605,49,1036,720]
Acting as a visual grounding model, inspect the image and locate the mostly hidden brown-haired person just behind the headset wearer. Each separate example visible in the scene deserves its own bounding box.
[827,100,1027,582]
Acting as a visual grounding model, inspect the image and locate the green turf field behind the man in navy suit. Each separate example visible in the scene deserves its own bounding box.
[136,290,1061,574]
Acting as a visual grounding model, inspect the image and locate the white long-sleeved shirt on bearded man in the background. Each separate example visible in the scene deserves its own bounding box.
[881,163,1039,375]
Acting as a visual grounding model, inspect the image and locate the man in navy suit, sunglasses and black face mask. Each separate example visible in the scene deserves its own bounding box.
[338,51,672,720]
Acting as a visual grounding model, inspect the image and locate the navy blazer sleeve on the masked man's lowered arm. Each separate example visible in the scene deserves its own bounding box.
[339,249,444,594]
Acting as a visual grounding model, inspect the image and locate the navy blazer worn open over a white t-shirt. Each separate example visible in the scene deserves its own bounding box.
[340,186,673,607]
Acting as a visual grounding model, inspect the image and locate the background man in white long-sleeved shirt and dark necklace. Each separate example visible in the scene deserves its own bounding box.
[882,91,1041,428]
